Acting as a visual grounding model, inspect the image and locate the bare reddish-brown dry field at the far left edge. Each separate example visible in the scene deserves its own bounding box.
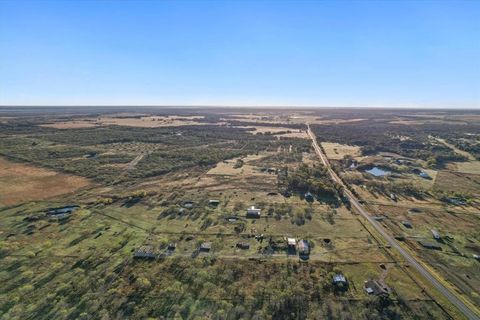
[0,158,90,206]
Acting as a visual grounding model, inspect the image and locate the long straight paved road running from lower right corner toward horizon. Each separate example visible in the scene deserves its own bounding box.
[307,124,480,320]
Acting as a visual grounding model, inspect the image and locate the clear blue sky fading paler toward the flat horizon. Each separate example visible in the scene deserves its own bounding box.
[0,0,480,108]
